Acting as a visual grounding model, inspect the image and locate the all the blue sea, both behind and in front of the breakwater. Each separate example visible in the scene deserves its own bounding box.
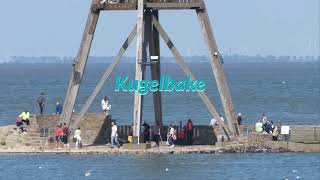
[0,63,320,180]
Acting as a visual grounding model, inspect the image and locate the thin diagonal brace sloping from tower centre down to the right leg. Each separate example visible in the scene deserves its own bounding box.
[153,17,229,137]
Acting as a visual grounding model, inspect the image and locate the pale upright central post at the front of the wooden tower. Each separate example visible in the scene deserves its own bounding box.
[133,0,144,143]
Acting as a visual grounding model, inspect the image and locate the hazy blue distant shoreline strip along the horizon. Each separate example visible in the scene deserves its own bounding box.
[0,54,320,64]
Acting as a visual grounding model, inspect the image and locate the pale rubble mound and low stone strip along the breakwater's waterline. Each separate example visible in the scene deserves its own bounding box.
[0,126,298,154]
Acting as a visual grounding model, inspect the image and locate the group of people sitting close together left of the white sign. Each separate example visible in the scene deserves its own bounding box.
[255,113,280,141]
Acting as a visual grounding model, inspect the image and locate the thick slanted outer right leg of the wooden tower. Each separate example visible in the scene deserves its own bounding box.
[197,7,240,135]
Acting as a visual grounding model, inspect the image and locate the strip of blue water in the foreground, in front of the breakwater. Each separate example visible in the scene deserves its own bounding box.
[0,153,320,180]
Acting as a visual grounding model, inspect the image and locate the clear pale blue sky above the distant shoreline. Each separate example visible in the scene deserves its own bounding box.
[0,0,320,57]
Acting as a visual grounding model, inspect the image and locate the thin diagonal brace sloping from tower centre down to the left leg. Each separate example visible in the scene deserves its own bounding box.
[71,26,137,129]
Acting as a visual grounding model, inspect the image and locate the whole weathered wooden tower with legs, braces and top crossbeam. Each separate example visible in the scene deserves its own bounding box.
[61,0,239,142]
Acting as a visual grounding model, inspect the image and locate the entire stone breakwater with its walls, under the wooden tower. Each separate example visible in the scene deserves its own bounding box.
[0,113,320,154]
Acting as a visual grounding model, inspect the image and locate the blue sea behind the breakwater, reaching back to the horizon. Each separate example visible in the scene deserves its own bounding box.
[0,62,320,125]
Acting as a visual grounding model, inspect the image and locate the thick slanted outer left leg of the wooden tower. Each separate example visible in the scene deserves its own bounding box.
[61,0,100,126]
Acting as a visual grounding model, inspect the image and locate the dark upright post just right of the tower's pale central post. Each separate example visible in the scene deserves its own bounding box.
[149,10,163,128]
